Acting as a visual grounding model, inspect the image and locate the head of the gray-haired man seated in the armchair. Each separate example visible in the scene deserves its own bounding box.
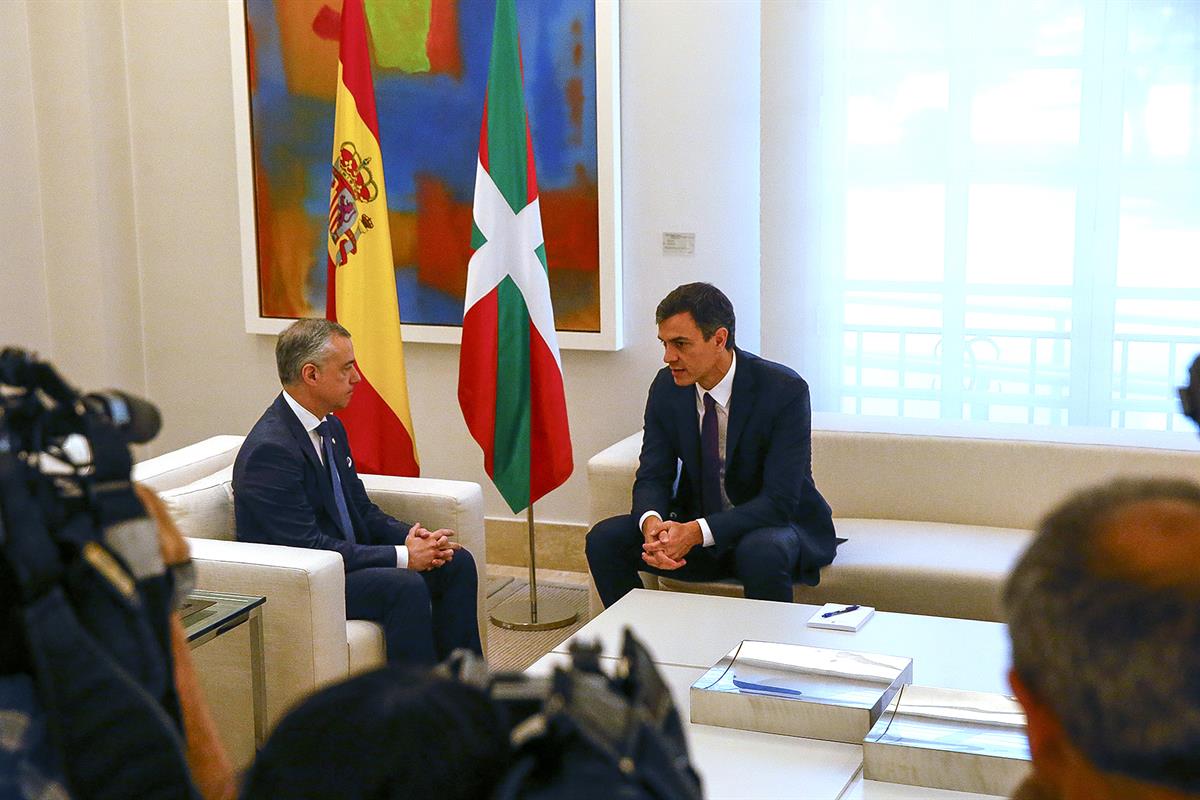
[275,319,361,419]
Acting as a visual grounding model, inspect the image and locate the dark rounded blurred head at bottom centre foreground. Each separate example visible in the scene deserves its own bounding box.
[241,667,509,800]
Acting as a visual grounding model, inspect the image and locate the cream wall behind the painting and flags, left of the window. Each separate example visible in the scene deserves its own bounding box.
[0,0,761,532]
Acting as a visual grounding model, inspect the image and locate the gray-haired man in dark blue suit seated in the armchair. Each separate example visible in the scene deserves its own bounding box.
[233,319,481,664]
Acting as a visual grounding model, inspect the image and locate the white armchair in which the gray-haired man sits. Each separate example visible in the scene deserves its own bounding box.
[133,435,487,726]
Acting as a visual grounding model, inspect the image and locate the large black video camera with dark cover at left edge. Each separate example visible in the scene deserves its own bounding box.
[0,348,198,799]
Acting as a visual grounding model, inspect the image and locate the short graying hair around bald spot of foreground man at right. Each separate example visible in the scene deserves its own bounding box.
[1004,479,1200,792]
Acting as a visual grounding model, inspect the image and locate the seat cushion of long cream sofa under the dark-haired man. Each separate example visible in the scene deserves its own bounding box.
[659,519,1032,621]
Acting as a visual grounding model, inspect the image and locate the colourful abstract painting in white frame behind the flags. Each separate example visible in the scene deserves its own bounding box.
[230,0,619,349]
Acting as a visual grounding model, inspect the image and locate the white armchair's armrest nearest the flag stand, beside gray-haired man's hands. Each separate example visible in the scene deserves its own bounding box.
[359,475,487,648]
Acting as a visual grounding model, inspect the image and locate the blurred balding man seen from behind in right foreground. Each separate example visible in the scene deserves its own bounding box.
[1004,480,1200,800]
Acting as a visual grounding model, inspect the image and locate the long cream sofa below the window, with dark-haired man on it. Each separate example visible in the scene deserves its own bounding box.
[588,414,1200,621]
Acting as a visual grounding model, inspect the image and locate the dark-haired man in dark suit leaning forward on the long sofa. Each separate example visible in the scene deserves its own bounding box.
[587,283,836,606]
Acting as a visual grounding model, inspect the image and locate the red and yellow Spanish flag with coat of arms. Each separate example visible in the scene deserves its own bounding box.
[325,0,420,476]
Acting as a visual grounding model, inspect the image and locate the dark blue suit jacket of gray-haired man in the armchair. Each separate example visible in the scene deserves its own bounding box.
[233,393,410,572]
